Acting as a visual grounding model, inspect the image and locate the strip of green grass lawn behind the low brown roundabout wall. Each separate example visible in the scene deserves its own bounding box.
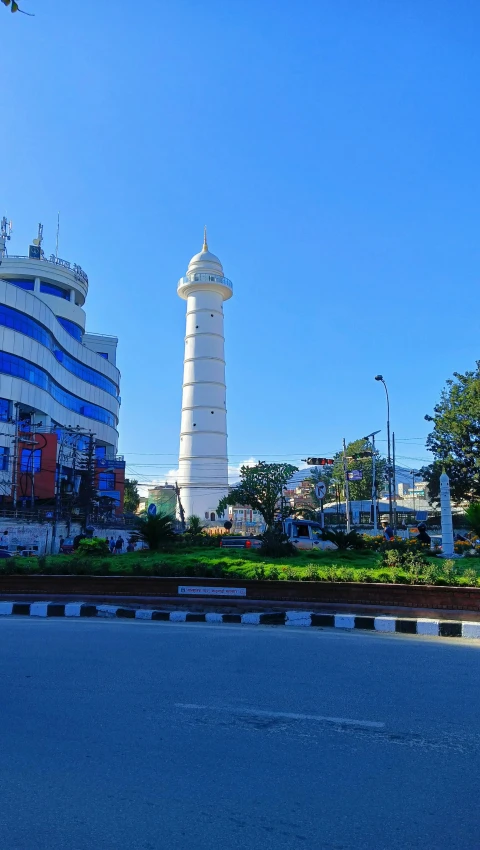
[0,548,480,586]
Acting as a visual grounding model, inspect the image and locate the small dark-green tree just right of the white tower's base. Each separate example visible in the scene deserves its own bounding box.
[217,460,297,528]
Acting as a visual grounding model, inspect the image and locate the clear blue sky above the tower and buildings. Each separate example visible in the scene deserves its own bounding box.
[0,0,480,481]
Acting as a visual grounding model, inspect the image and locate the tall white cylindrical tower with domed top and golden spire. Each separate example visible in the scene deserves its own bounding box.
[177,228,233,521]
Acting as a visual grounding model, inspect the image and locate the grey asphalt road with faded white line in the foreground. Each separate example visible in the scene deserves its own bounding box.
[0,618,480,850]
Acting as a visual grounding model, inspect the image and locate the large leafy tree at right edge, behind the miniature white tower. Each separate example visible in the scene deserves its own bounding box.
[421,360,480,502]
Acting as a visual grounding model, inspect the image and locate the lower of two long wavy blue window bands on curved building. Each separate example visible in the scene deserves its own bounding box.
[0,351,117,428]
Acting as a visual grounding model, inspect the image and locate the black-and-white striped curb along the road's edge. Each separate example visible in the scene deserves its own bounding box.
[0,602,480,639]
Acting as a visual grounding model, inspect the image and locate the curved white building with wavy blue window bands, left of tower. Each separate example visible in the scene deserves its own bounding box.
[0,229,120,510]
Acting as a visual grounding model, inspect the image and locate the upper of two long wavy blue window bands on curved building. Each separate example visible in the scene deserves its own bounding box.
[0,304,118,398]
